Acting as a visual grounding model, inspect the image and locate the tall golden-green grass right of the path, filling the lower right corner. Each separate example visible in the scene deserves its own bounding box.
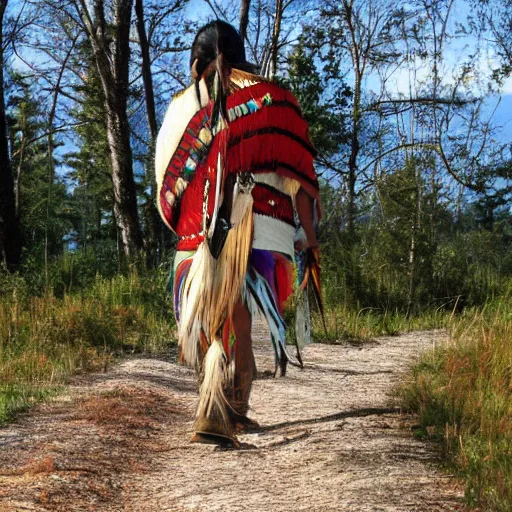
[399,299,512,512]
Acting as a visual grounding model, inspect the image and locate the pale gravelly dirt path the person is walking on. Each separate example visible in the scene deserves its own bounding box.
[0,331,464,512]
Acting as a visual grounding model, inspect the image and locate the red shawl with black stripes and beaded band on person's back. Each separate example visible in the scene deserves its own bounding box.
[158,75,319,250]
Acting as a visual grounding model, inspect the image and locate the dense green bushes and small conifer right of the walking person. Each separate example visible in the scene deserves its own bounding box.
[319,161,512,316]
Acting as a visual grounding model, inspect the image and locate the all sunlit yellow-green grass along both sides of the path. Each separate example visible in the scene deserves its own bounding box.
[0,256,512,512]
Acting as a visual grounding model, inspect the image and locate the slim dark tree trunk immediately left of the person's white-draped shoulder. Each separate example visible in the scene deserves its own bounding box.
[135,0,162,266]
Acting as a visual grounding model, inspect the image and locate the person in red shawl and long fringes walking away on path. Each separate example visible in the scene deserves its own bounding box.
[155,20,320,446]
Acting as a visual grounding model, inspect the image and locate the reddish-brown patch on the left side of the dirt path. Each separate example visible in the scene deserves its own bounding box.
[0,384,184,510]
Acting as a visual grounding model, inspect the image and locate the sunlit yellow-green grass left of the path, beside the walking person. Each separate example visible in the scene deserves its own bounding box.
[0,272,175,423]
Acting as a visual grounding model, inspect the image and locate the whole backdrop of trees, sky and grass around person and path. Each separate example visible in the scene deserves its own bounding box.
[0,0,512,510]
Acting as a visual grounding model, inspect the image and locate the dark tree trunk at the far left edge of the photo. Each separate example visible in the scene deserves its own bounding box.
[0,0,21,269]
